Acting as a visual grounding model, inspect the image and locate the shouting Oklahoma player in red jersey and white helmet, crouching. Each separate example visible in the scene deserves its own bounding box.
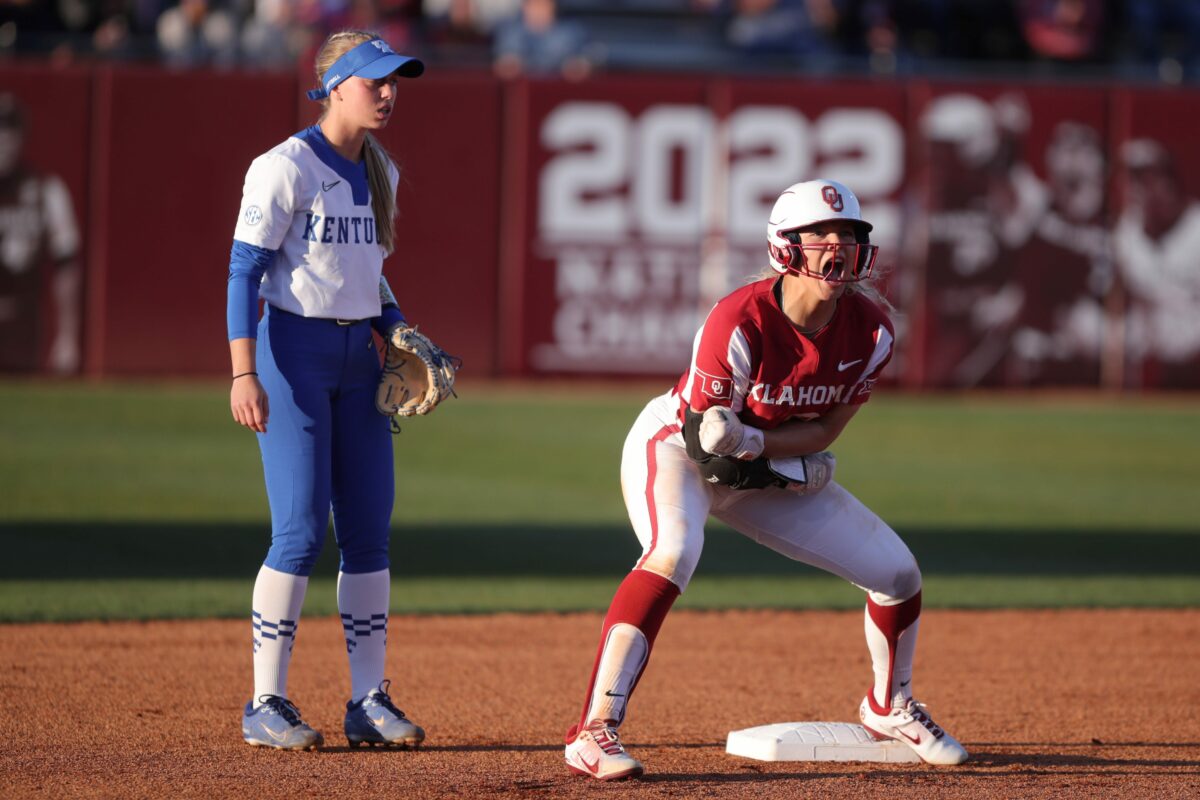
[565,180,967,781]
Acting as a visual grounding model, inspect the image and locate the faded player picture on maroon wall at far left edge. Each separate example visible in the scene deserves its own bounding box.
[0,89,86,375]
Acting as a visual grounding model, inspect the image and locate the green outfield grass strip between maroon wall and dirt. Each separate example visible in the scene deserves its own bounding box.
[0,381,1200,620]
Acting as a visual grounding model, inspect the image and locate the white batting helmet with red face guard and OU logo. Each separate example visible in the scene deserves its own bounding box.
[767,179,880,283]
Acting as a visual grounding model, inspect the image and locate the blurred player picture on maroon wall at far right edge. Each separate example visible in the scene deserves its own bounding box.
[1114,92,1200,389]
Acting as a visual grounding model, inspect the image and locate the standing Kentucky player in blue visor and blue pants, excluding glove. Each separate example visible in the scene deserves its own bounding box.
[228,31,425,750]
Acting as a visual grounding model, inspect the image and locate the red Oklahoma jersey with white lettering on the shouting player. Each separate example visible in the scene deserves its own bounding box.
[674,278,895,431]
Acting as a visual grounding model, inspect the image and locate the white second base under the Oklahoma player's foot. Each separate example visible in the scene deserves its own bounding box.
[725,722,920,764]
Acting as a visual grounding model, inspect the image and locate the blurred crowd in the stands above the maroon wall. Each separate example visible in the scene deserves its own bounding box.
[0,0,1200,83]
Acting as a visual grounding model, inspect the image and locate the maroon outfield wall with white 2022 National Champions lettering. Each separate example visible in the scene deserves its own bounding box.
[0,65,1200,387]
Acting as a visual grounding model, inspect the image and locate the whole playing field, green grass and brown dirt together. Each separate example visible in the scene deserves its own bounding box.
[0,381,1200,800]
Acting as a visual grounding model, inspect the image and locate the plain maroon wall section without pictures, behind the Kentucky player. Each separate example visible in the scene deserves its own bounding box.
[79,70,499,375]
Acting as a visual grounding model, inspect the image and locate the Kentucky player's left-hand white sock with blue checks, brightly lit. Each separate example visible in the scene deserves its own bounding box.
[251,565,308,705]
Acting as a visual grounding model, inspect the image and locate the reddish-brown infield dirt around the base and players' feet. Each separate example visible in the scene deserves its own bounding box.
[0,609,1200,800]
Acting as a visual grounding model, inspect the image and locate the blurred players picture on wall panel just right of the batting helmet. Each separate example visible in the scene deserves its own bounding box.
[906,86,1112,387]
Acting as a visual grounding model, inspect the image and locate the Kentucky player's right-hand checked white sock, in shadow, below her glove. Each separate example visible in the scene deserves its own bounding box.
[337,570,391,702]
